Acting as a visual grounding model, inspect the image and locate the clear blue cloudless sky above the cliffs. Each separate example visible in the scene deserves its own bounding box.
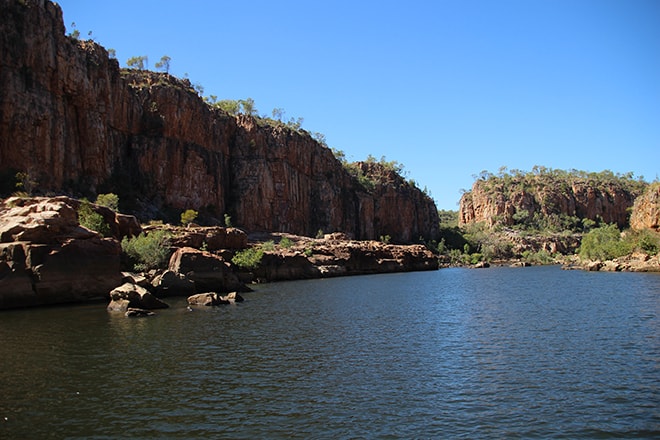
[58,0,660,210]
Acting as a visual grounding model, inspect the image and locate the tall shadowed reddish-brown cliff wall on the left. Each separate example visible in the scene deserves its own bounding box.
[0,0,439,243]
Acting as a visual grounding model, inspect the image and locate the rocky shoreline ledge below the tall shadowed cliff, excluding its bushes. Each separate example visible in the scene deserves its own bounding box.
[0,196,439,312]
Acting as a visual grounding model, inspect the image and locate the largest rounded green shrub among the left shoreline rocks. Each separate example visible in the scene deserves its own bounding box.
[121,230,170,271]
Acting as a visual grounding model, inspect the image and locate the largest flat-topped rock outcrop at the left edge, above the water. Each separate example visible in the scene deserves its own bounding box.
[0,197,122,309]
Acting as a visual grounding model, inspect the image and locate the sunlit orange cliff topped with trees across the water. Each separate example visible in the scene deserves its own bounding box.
[459,167,647,230]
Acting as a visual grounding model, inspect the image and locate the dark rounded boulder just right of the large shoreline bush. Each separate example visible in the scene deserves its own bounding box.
[169,247,248,292]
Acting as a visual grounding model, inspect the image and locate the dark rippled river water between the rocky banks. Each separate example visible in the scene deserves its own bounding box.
[0,267,660,439]
